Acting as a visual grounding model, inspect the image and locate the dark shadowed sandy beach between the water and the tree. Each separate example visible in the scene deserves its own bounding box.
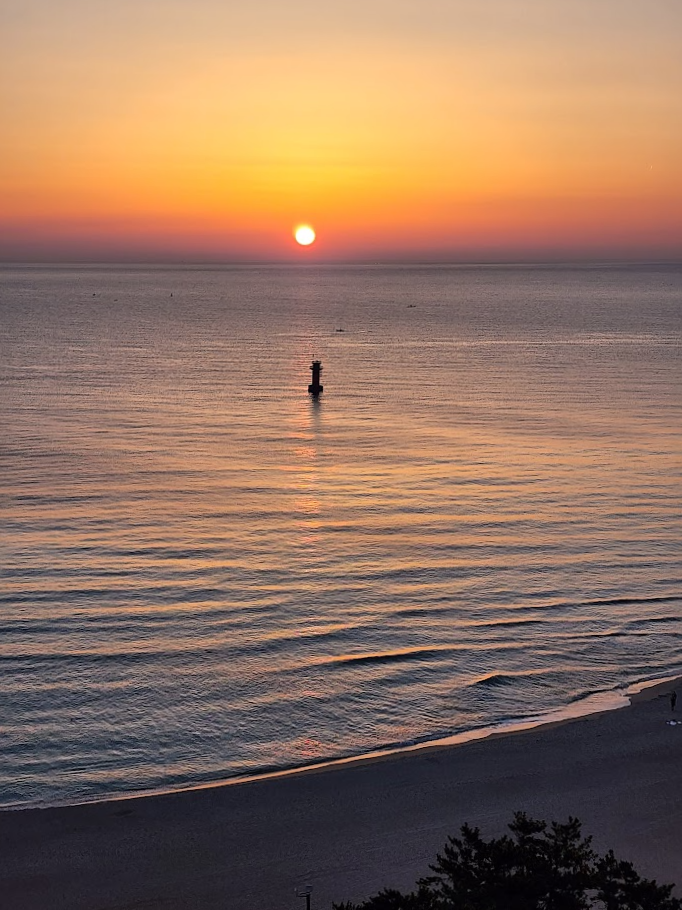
[0,683,682,910]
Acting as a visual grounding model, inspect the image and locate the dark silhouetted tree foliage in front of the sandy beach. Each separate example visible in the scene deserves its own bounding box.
[334,812,682,910]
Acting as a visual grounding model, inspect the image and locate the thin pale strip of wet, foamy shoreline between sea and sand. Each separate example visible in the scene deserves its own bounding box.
[0,675,682,815]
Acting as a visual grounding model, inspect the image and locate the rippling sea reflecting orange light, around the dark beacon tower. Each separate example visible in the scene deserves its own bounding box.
[0,266,682,807]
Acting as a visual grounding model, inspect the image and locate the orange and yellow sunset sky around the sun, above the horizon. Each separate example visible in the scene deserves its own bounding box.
[0,0,682,262]
